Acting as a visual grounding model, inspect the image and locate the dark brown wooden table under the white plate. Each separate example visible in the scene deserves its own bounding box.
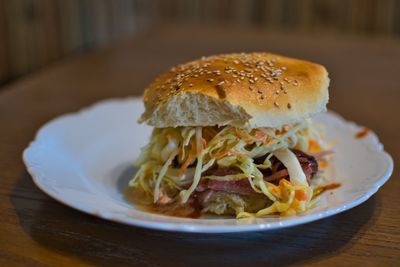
[0,26,400,267]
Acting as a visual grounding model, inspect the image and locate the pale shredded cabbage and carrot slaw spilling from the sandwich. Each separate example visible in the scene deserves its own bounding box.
[129,120,327,218]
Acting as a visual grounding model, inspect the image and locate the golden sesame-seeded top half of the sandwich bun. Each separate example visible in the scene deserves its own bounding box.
[139,53,329,128]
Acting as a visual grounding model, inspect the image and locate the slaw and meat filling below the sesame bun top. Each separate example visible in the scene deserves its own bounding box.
[129,119,327,218]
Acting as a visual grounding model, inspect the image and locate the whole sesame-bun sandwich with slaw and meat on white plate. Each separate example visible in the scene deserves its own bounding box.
[129,53,329,218]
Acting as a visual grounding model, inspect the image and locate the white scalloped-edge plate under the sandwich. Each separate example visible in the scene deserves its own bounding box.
[24,99,393,233]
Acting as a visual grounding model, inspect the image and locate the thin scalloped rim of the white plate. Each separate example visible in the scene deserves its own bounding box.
[22,97,394,233]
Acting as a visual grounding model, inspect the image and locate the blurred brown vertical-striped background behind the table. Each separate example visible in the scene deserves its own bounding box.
[0,0,400,85]
